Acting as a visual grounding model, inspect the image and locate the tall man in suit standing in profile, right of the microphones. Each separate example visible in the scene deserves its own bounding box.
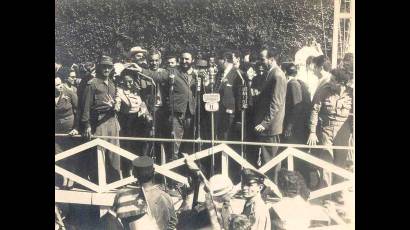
[252,48,287,182]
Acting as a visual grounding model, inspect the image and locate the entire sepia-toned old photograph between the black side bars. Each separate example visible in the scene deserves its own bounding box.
[55,0,355,230]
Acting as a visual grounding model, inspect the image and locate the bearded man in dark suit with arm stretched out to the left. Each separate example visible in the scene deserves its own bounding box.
[125,52,197,160]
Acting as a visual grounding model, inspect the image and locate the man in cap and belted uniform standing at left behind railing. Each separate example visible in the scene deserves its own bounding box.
[81,55,121,182]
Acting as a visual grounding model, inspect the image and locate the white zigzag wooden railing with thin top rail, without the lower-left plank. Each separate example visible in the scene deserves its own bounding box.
[55,134,354,199]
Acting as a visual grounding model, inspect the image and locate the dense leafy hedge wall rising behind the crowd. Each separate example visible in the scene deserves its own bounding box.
[55,0,333,63]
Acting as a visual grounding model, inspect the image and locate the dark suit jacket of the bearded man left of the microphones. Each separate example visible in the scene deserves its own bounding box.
[142,68,197,115]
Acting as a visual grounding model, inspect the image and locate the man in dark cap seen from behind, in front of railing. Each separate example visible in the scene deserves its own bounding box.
[117,156,177,230]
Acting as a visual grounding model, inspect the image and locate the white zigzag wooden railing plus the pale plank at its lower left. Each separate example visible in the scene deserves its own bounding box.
[55,134,354,229]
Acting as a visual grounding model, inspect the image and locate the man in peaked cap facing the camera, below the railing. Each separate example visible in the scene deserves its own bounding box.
[242,168,271,230]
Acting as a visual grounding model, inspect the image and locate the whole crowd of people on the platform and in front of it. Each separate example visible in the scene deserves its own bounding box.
[55,38,353,229]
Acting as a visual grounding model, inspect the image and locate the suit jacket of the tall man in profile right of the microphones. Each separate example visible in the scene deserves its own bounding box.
[252,67,287,136]
